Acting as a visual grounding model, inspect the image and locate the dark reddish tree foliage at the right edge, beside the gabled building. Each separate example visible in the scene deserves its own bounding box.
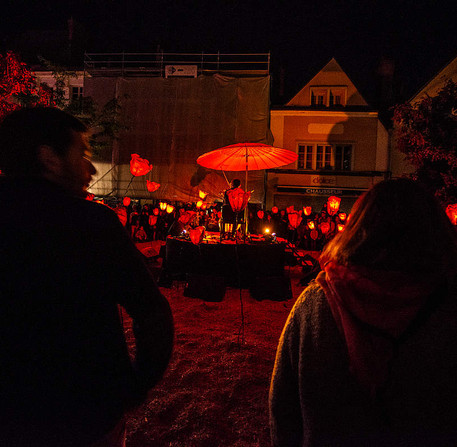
[394,81,457,204]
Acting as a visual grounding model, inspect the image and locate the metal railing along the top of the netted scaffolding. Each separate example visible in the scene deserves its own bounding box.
[84,52,270,77]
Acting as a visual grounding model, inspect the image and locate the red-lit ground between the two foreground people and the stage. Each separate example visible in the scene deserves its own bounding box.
[121,260,310,447]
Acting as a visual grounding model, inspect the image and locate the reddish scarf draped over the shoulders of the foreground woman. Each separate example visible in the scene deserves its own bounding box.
[316,262,437,398]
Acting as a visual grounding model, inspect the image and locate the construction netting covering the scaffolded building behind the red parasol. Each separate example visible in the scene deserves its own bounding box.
[85,74,273,202]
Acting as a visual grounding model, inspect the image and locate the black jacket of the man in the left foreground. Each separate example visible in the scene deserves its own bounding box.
[0,179,173,446]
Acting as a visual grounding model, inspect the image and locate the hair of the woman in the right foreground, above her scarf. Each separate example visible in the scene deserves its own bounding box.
[321,178,457,274]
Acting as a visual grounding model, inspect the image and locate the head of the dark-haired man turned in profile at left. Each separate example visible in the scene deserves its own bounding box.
[0,107,96,195]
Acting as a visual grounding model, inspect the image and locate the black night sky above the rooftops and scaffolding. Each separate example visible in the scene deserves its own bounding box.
[0,0,457,106]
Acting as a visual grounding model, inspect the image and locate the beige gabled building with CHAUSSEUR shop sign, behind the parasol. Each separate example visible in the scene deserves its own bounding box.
[266,59,390,211]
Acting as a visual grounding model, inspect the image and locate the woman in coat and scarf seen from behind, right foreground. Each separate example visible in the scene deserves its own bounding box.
[270,179,457,447]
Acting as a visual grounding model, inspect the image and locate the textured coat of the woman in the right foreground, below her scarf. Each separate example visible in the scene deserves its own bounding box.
[270,283,457,447]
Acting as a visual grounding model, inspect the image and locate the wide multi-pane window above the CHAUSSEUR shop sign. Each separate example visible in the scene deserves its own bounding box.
[297,143,352,171]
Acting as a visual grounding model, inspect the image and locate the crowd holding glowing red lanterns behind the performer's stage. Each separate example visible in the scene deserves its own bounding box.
[109,201,347,251]
